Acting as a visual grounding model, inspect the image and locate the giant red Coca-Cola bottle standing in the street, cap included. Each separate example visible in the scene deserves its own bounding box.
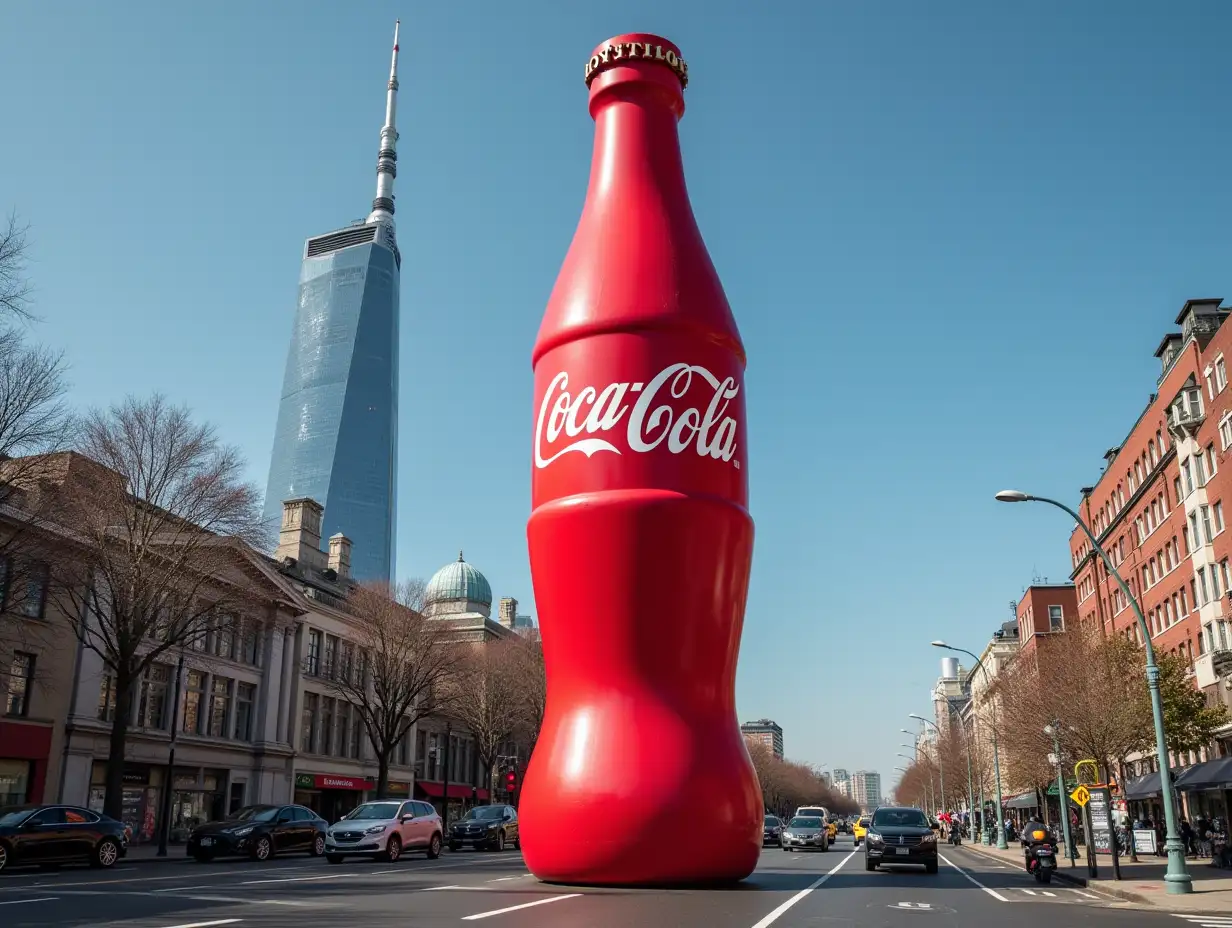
[520,33,763,885]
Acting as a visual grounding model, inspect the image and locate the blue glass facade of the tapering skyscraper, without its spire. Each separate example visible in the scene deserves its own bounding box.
[265,223,399,580]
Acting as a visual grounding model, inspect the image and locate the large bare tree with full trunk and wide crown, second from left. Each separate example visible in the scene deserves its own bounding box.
[51,396,264,818]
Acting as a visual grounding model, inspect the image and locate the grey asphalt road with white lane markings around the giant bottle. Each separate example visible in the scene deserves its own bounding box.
[0,838,1217,928]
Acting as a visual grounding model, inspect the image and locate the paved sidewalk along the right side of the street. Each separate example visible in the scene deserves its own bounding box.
[962,842,1232,914]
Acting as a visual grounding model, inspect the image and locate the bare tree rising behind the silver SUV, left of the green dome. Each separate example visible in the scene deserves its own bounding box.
[329,580,460,799]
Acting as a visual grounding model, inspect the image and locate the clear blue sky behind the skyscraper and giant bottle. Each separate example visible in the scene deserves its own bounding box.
[0,0,1232,783]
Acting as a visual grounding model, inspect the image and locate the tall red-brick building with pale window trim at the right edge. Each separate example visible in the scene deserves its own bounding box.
[1069,299,1232,815]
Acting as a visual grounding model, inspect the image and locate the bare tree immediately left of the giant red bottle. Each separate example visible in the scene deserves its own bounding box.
[448,641,526,796]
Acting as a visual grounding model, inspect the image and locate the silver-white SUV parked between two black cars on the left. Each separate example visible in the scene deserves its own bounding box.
[325,799,441,864]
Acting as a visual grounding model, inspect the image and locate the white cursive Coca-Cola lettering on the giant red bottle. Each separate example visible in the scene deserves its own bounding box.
[535,362,740,468]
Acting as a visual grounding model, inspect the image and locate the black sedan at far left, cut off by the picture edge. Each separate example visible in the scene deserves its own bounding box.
[0,805,132,871]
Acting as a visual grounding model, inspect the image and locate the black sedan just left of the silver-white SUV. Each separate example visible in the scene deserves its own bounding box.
[187,806,328,863]
